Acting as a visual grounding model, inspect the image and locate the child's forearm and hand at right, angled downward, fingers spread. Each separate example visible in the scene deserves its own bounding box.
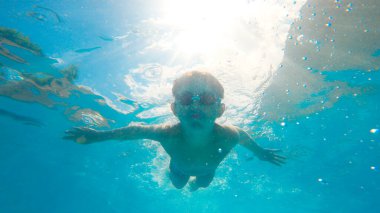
[238,129,286,166]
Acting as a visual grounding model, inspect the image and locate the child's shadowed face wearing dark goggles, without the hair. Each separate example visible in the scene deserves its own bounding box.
[172,80,224,129]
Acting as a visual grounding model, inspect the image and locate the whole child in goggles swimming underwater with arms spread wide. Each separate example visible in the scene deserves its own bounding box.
[64,71,286,191]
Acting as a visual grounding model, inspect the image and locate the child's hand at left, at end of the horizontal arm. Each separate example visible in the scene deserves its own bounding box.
[63,127,99,144]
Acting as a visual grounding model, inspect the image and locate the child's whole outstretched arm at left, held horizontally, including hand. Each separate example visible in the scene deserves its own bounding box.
[63,125,168,144]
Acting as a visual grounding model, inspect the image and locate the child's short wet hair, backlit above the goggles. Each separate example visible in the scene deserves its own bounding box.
[172,71,224,98]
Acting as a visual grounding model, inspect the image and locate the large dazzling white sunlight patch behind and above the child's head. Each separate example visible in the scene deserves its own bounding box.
[130,0,306,124]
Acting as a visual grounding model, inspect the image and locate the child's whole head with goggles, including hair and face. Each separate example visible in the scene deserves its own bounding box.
[171,71,225,127]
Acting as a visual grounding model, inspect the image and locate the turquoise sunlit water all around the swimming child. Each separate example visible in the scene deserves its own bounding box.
[0,0,380,212]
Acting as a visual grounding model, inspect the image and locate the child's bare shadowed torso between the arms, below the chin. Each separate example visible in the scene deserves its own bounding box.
[160,124,239,176]
